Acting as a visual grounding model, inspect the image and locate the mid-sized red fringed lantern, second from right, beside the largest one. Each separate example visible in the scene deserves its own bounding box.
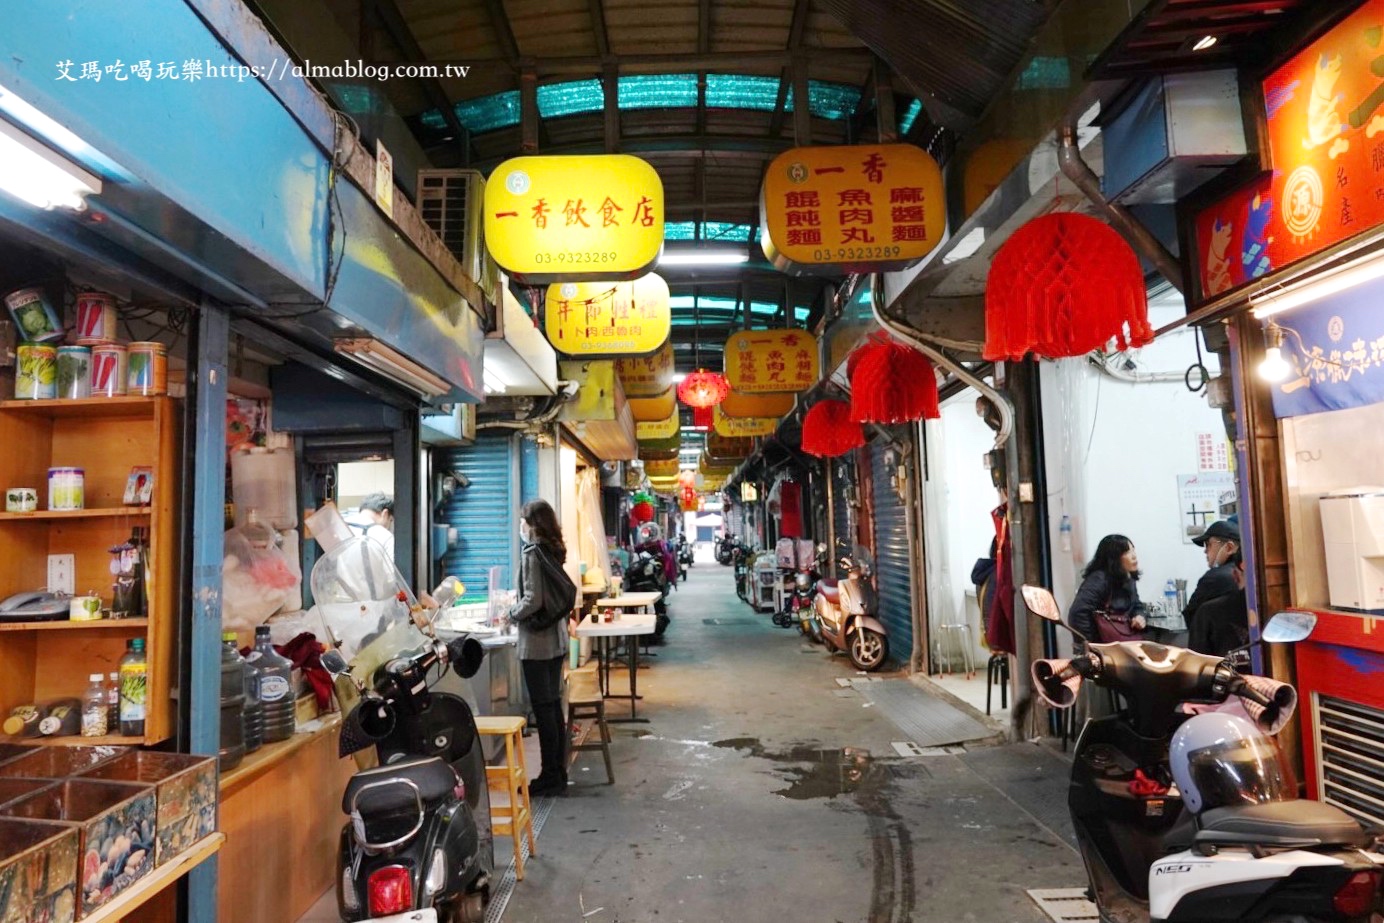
[851,336,943,423]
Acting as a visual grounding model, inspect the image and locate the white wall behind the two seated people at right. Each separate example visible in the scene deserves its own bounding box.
[1041,300,1225,628]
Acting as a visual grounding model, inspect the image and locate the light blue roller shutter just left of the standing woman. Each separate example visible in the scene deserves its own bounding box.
[443,432,519,594]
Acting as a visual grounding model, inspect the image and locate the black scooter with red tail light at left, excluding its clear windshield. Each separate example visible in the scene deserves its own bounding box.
[322,628,494,923]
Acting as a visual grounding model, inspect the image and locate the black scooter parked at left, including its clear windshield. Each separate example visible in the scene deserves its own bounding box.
[313,538,494,923]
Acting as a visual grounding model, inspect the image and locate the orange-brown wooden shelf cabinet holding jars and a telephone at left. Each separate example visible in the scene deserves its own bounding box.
[0,397,179,743]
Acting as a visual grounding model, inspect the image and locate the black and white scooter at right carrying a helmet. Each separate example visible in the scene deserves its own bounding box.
[1023,587,1384,923]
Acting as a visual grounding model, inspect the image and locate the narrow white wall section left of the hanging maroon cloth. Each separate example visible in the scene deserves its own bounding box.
[923,390,999,668]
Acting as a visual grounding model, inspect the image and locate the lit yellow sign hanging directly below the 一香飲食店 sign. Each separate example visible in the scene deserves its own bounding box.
[543,273,673,357]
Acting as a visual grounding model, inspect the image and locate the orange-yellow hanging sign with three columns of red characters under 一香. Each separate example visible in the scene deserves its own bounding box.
[760,144,947,274]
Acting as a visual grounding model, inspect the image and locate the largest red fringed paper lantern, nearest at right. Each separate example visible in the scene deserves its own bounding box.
[984,212,1153,360]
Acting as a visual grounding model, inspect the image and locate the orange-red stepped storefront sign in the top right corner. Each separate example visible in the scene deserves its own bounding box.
[1196,0,1384,299]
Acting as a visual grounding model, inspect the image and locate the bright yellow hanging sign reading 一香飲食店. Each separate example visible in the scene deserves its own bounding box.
[484,154,663,285]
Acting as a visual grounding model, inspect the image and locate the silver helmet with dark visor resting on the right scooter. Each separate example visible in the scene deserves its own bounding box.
[1168,711,1293,814]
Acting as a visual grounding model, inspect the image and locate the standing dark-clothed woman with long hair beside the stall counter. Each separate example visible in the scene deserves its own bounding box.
[509,500,567,796]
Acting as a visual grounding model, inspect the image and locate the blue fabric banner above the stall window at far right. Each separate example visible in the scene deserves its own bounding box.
[1272,273,1384,418]
